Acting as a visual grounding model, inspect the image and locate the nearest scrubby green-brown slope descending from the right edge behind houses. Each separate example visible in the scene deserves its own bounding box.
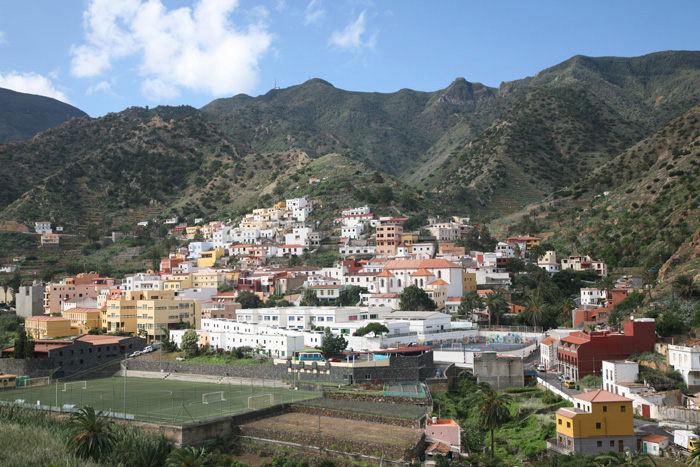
[495,105,700,280]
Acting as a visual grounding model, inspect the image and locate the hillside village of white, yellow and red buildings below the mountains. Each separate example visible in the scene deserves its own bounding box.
[0,194,700,459]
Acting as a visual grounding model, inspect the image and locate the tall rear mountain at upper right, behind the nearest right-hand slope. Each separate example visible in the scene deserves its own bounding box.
[418,52,700,215]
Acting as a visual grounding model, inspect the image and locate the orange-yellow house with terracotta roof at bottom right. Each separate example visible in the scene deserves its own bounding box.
[548,390,637,455]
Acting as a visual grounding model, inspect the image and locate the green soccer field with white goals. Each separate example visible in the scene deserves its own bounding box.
[0,377,321,424]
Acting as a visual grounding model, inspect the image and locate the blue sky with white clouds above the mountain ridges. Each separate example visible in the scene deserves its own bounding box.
[0,0,700,117]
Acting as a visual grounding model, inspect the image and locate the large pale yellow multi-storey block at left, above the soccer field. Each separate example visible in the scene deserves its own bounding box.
[102,290,202,342]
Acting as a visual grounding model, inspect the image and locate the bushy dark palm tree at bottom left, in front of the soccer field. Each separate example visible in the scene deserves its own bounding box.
[68,405,117,462]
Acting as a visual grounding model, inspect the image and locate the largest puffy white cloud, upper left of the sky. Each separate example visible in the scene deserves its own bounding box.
[71,0,272,100]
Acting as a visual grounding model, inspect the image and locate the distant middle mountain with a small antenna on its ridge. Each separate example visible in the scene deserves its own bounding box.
[201,79,493,176]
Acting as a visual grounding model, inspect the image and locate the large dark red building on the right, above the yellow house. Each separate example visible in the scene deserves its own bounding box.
[557,318,656,380]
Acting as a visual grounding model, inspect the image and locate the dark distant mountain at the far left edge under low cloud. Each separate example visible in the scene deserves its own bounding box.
[0,88,87,143]
